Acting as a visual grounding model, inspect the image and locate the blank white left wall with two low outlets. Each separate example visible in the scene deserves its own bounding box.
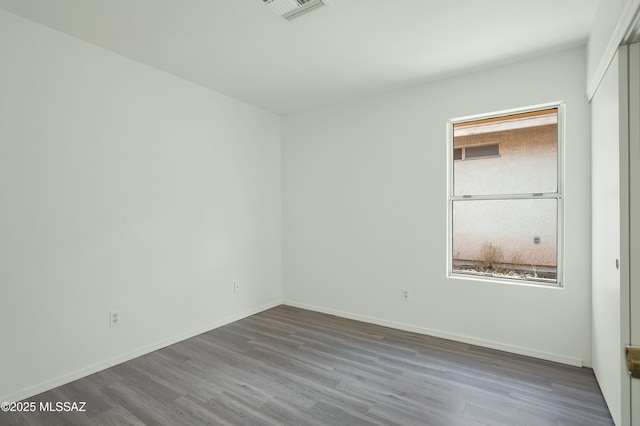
[0,11,282,401]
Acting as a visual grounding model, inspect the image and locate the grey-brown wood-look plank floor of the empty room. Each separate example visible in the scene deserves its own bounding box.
[0,306,613,426]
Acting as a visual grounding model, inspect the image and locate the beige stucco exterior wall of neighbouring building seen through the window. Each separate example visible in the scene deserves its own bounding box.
[453,124,558,267]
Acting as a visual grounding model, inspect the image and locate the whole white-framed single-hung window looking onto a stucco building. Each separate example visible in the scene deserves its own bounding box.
[447,103,564,286]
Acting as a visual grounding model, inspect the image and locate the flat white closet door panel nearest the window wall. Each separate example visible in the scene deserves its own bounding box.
[591,51,622,425]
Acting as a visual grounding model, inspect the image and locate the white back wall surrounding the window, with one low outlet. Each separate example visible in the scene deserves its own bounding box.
[282,48,591,365]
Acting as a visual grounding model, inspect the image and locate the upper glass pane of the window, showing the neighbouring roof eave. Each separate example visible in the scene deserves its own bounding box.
[452,109,558,196]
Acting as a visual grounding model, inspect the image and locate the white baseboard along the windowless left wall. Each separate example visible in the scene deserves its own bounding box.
[0,300,282,402]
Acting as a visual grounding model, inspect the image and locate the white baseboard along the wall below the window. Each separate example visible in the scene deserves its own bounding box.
[282,299,584,367]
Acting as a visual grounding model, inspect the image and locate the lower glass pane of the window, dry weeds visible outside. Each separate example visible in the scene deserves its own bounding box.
[452,199,558,283]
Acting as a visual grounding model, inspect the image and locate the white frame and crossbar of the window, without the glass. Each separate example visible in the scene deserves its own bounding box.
[446,101,566,288]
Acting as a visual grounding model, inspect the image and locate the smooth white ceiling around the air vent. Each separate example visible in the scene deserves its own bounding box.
[0,0,598,114]
